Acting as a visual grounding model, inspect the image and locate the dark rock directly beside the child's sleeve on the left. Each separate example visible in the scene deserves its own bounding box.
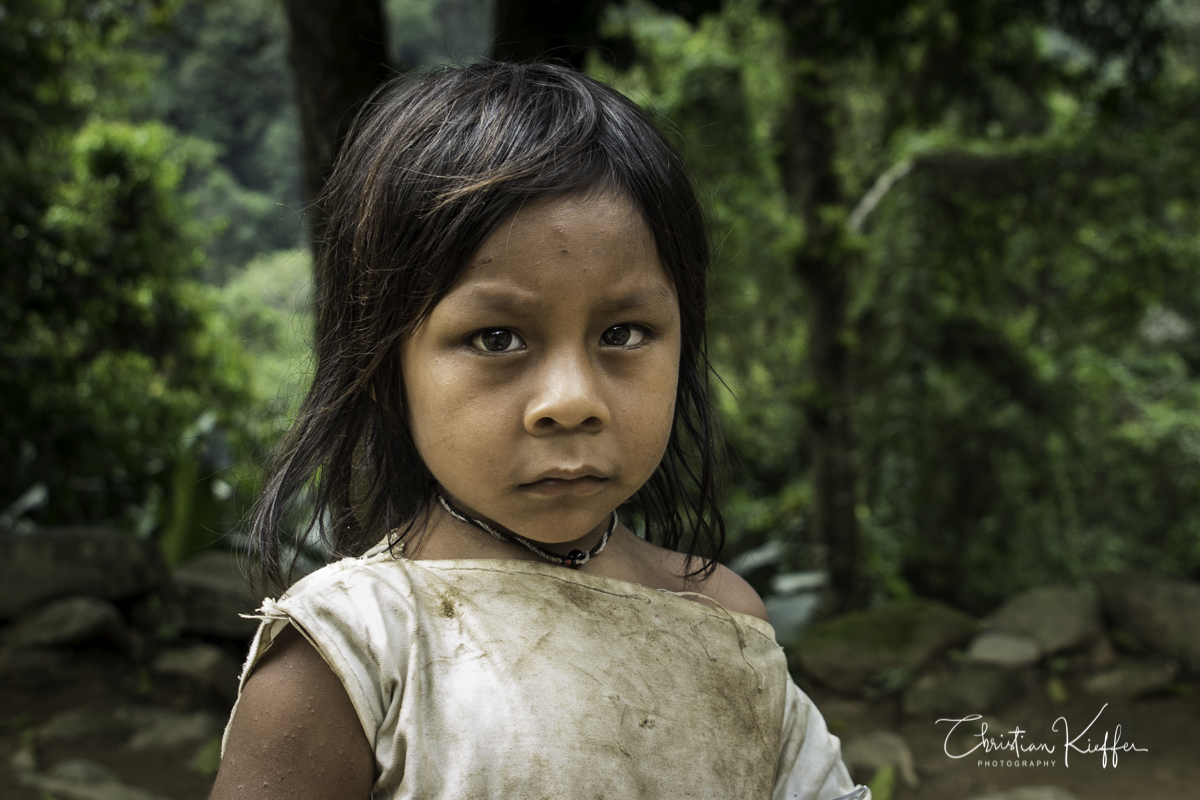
[174,551,262,640]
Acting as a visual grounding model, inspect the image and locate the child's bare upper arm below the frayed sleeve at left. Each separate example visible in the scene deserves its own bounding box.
[211,626,374,800]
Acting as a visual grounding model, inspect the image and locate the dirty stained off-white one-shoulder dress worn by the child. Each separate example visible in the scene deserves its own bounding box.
[227,546,868,800]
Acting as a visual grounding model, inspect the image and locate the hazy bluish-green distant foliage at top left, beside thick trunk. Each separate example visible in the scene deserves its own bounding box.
[118,0,305,283]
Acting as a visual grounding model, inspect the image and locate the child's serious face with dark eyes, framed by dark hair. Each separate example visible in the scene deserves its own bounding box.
[401,194,680,542]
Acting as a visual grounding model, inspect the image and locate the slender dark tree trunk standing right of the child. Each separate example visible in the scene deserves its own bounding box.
[779,2,864,612]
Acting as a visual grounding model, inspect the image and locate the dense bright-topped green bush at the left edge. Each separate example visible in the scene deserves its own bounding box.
[0,117,255,522]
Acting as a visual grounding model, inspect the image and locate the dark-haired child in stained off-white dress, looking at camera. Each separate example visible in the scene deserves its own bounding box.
[212,64,869,800]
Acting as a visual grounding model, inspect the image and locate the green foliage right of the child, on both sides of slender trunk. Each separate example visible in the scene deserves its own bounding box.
[604,0,1200,610]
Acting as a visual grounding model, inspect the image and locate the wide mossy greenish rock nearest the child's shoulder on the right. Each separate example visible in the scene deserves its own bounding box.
[794,600,974,692]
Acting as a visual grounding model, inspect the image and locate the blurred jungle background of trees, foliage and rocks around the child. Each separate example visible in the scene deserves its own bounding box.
[0,0,1200,800]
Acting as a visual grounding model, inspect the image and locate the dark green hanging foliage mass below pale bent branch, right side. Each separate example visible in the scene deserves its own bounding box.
[860,131,1200,607]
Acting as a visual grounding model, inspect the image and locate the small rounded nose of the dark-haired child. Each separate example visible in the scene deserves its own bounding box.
[524,353,610,435]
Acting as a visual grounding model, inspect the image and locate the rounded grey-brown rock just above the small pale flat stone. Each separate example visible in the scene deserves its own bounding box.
[983,587,1100,654]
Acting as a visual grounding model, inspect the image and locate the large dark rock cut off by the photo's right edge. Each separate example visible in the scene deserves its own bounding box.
[1097,572,1200,673]
